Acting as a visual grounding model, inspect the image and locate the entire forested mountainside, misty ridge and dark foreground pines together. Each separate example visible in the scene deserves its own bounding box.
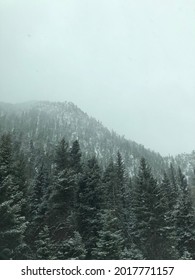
[0,102,195,259]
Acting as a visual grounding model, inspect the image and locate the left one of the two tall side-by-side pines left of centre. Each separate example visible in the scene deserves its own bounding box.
[47,139,78,242]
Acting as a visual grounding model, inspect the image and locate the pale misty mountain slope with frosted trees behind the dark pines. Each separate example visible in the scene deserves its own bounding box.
[0,101,195,179]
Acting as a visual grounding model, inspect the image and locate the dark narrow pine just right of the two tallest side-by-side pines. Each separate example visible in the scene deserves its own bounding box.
[78,157,103,259]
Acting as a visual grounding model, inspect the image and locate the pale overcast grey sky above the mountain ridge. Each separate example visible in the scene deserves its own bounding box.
[0,0,195,155]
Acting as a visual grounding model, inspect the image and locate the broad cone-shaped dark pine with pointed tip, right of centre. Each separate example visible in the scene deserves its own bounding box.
[133,158,177,259]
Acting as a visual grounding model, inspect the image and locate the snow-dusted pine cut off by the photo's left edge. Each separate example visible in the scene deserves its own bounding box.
[0,134,26,259]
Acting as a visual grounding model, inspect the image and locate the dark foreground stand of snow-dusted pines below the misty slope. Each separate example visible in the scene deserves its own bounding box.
[0,128,195,260]
